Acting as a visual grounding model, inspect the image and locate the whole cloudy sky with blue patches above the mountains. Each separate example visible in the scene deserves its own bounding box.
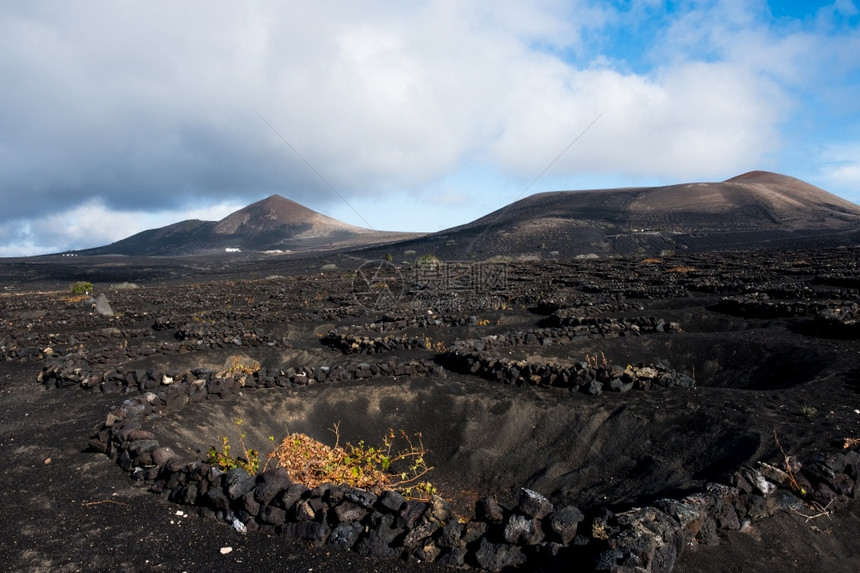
[0,0,860,256]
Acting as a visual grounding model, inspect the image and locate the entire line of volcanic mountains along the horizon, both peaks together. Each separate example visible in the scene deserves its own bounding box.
[72,171,860,259]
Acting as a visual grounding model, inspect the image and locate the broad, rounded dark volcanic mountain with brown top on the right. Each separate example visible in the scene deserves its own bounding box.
[372,171,860,260]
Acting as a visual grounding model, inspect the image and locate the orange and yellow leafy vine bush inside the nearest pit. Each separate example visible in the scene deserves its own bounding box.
[266,424,436,498]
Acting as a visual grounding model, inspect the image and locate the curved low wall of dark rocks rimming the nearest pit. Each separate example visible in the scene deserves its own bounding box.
[84,368,860,573]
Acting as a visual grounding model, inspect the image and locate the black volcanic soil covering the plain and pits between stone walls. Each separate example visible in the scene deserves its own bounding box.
[0,249,860,572]
